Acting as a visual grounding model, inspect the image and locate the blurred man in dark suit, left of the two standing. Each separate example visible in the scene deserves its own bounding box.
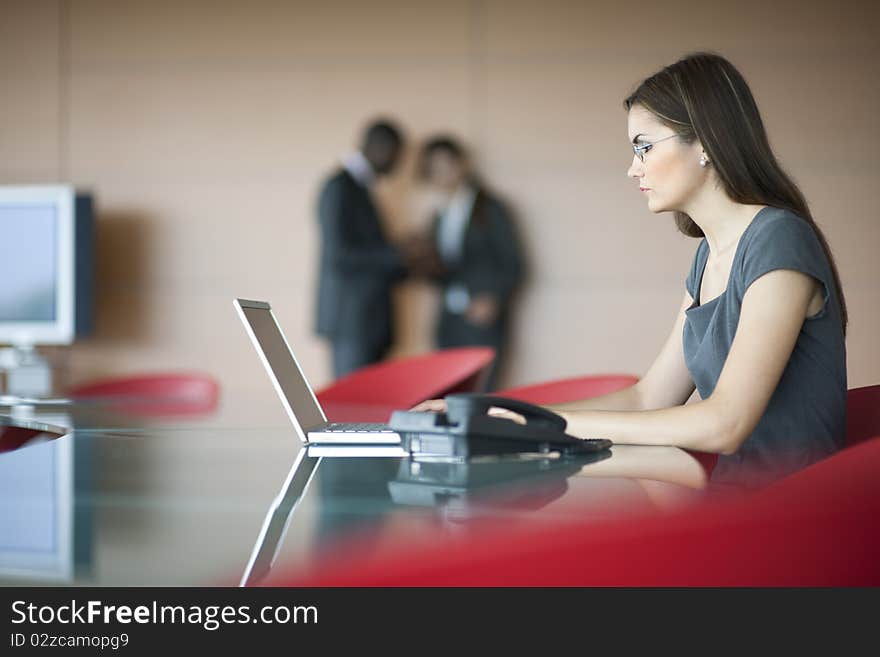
[317,121,427,378]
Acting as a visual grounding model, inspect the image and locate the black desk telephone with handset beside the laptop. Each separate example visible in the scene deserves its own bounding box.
[388,393,611,458]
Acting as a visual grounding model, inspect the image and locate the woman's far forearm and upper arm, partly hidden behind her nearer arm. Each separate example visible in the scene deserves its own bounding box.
[547,292,694,413]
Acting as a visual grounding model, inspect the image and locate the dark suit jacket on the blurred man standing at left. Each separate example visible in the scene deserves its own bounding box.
[317,169,403,347]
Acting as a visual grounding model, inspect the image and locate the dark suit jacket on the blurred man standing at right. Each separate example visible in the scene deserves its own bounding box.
[432,189,525,348]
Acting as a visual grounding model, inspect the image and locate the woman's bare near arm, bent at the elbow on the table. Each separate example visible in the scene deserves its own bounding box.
[562,270,818,454]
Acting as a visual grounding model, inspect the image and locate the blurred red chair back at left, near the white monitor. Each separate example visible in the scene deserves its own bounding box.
[67,373,220,415]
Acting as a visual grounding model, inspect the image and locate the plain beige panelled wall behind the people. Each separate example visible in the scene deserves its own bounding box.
[0,0,880,392]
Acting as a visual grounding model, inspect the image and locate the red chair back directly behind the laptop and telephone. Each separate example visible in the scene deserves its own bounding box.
[317,347,495,412]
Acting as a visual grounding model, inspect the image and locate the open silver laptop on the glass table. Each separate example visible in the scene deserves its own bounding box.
[234,299,406,448]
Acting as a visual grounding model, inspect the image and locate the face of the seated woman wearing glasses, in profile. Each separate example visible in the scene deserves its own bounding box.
[626,105,708,213]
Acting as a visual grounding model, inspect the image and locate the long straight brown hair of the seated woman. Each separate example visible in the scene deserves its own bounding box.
[623,53,847,334]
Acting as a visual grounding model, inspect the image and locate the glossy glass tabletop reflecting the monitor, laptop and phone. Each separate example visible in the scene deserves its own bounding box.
[0,400,705,586]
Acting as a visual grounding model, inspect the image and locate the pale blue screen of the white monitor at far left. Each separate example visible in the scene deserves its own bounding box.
[0,203,58,322]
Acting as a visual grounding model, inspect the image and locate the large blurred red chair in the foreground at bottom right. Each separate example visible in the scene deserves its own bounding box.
[278,437,880,586]
